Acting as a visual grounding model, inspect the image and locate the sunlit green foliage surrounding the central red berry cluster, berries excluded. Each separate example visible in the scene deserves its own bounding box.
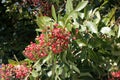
[24,0,120,80]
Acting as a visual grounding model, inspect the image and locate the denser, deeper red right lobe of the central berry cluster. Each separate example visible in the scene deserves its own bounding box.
[51,28,70,54]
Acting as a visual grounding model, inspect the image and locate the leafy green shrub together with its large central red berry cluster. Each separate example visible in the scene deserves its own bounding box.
[0,0,120,80]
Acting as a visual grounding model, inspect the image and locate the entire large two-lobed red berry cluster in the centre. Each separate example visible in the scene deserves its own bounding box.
[23,28,70,61]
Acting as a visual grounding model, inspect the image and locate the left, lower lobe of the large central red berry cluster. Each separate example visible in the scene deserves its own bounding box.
[23,34,47,61]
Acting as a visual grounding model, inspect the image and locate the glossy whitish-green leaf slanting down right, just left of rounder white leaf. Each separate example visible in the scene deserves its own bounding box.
[85,21,98,33]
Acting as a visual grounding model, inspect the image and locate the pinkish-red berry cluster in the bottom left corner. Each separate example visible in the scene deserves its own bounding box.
[0,64,31,80]
